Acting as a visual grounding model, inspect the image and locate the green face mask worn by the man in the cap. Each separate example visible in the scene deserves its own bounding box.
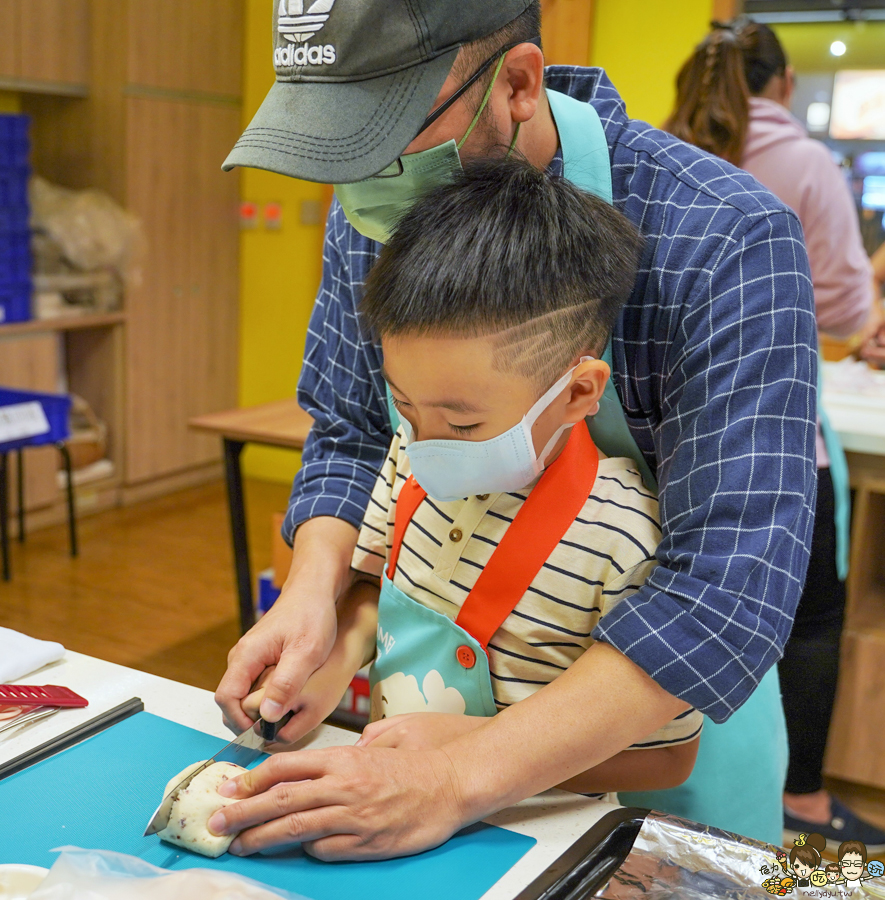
[334,56,519,244]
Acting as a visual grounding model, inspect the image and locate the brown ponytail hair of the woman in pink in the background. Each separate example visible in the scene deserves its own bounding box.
[664,16,787,165]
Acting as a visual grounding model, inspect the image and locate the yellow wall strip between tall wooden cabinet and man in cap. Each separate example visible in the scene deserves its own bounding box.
[239,0,323,482]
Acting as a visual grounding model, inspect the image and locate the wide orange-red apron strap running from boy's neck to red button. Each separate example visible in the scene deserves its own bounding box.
[456,421,599,652]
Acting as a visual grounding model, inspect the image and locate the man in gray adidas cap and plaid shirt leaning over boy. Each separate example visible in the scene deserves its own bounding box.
[213,0,817,858]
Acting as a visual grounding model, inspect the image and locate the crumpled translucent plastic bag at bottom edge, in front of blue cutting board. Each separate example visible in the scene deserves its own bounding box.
[31,847,306,900]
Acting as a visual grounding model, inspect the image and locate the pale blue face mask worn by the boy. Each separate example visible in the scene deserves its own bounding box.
[400,356,593,501]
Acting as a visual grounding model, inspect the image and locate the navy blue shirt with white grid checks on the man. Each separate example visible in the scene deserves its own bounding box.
[284,66,817,722]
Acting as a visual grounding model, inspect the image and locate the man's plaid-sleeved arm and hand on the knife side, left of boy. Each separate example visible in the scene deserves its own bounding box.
[216,201,390,740]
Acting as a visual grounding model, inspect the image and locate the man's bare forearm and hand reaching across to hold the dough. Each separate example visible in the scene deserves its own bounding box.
[210,644,687,859]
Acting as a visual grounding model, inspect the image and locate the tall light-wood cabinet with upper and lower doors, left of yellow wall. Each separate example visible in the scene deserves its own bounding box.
[12,0,243,502]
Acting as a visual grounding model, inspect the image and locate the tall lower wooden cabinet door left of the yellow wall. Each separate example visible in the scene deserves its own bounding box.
[126,98,240,481]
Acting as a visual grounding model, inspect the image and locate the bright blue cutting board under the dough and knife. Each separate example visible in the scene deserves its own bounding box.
[0,712,535,900]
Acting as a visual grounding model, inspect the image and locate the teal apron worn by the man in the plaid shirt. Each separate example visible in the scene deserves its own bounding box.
[382,90,784,845]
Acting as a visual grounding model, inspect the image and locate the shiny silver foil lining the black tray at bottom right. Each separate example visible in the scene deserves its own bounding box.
[596,812,885,900]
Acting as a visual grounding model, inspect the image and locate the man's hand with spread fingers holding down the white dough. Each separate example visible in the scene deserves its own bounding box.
[209,747,466,860]
